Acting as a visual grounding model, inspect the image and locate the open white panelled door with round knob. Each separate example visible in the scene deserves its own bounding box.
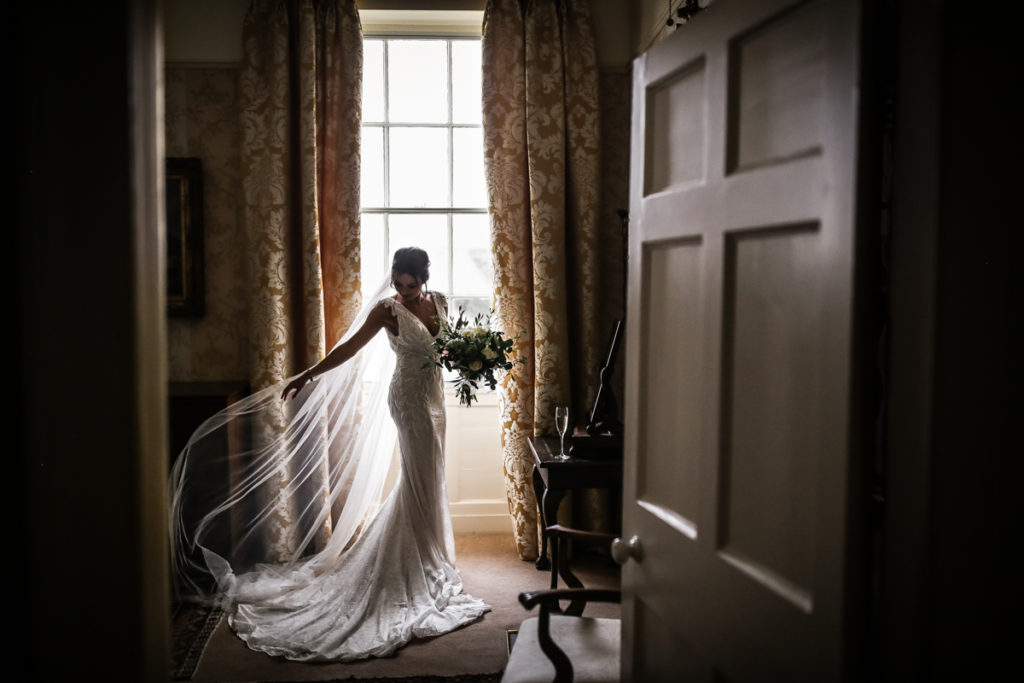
[617,0,861,682]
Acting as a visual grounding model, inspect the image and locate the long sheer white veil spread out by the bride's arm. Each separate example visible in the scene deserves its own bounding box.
[170,278,396,605]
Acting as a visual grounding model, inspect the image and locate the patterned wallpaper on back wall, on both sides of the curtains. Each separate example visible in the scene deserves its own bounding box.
[165,67,631,397]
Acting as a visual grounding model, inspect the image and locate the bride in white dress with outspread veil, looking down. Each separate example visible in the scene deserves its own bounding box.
[171,247,489,661]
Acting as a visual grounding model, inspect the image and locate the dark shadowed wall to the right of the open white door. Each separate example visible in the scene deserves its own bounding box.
[883,0,1024,681]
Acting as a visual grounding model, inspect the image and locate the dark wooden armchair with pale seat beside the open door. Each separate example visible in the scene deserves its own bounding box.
[502,524,622,683]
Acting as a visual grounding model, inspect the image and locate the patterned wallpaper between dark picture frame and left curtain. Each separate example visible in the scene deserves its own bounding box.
[164,67,249,382]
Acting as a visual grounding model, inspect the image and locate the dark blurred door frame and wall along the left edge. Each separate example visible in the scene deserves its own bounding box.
[15,0,169,681]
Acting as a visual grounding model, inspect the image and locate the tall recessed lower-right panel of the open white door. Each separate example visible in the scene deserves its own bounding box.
[719,223,822,610]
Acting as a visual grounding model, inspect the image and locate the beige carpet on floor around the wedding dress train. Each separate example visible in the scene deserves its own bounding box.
[193,533,618,683]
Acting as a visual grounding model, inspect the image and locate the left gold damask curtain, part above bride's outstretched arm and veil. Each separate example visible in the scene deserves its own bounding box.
[241,0,362,391]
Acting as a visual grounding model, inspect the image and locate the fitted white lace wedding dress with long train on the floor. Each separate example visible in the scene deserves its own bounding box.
[172,294,489,661]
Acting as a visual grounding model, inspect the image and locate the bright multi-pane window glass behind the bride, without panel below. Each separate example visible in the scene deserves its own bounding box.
[360,36,493,325]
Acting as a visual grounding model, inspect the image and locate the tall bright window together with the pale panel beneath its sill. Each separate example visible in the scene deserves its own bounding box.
[359,18,511,533]
